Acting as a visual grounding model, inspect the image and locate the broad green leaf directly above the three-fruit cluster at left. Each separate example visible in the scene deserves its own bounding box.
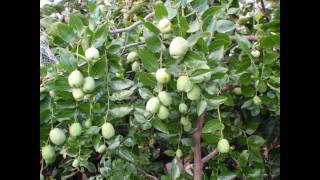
[59,48,78,72]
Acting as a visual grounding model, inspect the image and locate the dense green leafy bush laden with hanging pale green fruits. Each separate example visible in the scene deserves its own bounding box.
[40,0,280,180]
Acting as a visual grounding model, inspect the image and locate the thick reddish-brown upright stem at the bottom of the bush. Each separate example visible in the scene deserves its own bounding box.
[193,113,204,180]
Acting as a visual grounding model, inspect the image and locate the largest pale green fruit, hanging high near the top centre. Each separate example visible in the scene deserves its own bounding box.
[169,37,189,59]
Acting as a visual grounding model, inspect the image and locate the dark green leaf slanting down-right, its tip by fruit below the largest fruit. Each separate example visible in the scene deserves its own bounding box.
[138,49,159,72]
